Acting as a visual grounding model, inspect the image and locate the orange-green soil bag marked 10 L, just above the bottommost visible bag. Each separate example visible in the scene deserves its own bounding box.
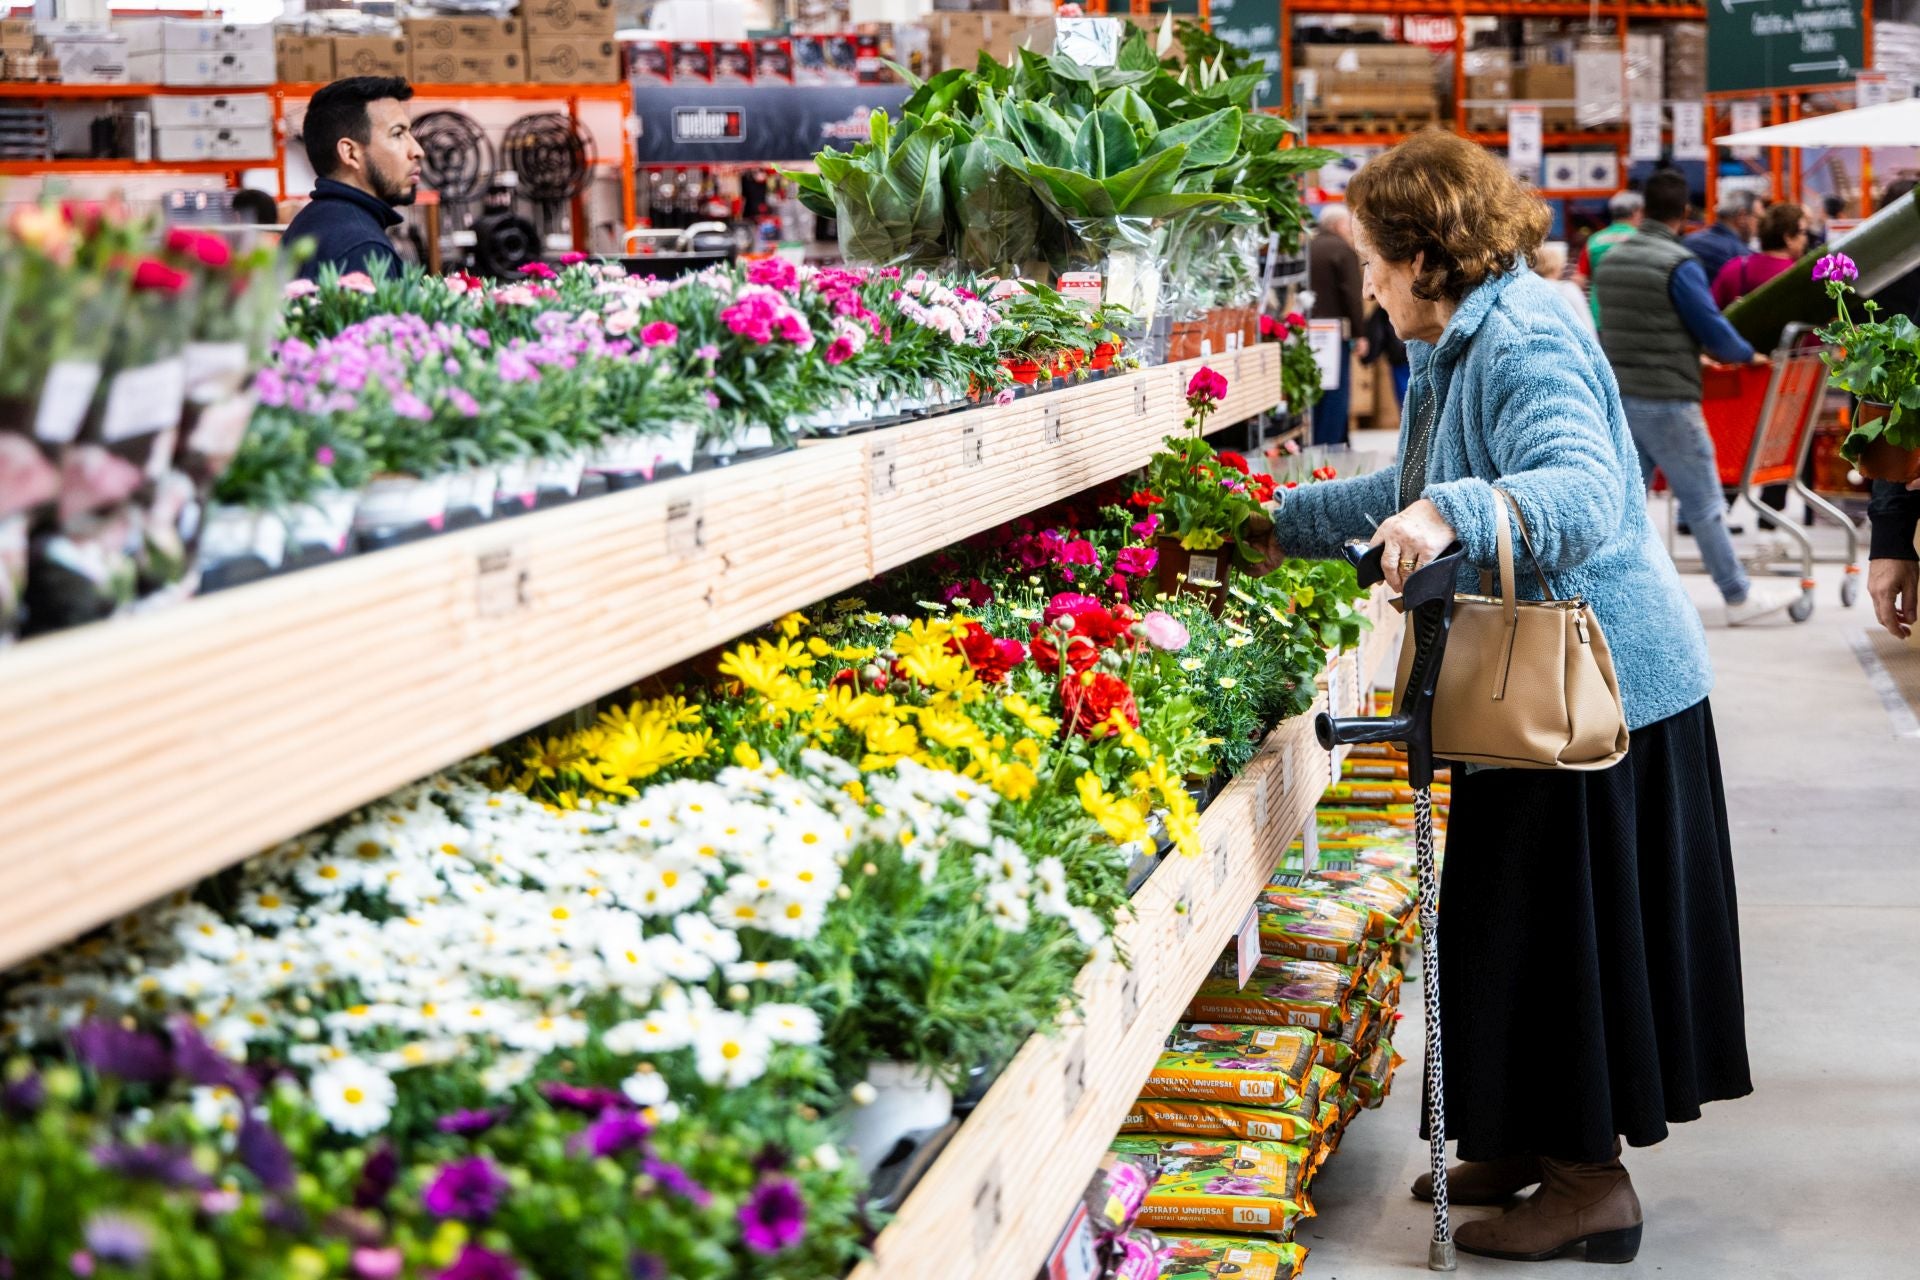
[1112,1134,1313,1236]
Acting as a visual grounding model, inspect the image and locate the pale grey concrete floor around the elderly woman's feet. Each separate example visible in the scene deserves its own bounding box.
[1300,516,1920,1280]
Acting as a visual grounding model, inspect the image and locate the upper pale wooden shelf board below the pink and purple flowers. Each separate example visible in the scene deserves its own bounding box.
[0,347,1281,969]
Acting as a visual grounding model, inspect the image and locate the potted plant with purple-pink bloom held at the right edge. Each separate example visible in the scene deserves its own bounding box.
[1812,253,1920,484]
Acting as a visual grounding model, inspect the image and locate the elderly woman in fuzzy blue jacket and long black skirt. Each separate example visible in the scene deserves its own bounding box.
[1275,132,1753,1263]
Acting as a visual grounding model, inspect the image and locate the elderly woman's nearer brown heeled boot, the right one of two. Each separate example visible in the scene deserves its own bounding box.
[1453,1159,1642,1263]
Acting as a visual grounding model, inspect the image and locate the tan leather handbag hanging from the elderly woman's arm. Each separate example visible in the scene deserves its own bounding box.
[1394,489,1626,770]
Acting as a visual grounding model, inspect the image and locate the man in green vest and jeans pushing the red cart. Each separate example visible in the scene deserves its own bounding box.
[1594,169,1799,628]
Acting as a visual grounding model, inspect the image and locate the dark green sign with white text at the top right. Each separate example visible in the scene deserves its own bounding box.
[1707,0,1866,94]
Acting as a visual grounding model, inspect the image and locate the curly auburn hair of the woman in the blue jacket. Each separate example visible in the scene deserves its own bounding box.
[1346,129,1553,303]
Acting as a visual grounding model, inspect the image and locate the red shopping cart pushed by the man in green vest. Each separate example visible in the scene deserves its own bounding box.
[1657,324,1860,622]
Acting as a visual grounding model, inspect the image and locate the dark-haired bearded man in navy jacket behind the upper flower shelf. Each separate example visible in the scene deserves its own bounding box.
[280,75,426,280]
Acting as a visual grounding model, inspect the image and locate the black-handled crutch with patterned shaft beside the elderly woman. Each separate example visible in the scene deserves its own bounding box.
[1313,543,1465,1270]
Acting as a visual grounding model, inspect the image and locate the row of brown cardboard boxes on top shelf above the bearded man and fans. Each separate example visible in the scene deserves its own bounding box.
[275,0,620,84]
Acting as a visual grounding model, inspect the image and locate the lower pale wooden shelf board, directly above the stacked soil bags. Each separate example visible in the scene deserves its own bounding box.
[849,589,1398,1280]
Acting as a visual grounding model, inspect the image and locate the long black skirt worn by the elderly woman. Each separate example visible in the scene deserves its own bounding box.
[1423,700,1753,1161]
